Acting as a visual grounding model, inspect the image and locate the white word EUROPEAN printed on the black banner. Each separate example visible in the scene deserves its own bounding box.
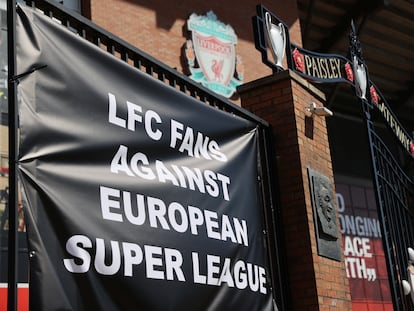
[99,186,249,246]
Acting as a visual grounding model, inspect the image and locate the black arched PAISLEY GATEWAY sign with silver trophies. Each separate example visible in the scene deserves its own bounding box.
[253,4,414,159]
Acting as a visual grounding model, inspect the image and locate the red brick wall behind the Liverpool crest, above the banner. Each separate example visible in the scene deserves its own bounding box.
[83,0,302,98]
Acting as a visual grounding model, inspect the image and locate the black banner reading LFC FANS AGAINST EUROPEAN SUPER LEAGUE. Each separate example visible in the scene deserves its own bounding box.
[17,8,273,311]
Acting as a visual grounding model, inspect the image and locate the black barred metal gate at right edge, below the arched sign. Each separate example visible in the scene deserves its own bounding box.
[365,105,414,310]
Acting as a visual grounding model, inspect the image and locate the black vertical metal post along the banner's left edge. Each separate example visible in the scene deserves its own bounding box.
[7,0,18,311]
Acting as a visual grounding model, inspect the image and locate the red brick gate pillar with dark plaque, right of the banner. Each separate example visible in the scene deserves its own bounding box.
[238,70,352,311]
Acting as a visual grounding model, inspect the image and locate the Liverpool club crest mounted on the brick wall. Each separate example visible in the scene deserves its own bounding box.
[185,11,244,98]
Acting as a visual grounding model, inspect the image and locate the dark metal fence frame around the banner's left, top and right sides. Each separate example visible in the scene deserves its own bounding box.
[4,0,287,311]
